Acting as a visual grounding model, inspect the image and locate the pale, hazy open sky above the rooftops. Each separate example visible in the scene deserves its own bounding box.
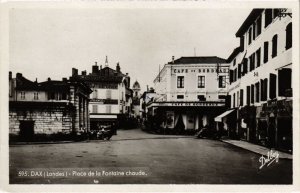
[9,8,251,91]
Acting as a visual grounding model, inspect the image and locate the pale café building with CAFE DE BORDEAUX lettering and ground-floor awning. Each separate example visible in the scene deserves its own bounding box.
[147,56,229,132]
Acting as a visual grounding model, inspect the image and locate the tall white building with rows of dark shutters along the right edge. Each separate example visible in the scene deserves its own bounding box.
[228,9,292,151]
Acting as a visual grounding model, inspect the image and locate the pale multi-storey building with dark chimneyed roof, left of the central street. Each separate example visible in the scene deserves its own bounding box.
[74,58,131,130]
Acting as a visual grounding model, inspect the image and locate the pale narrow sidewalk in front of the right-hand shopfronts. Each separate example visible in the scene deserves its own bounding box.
[221,139,293,159]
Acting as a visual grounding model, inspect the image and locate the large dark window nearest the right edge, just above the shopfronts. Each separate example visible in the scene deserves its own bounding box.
[278,68,292,96]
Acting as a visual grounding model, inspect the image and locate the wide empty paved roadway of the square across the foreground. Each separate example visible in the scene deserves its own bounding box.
[9,129,292,184]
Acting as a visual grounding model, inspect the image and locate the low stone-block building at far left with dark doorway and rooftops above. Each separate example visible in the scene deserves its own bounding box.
[9,72,91,141]
